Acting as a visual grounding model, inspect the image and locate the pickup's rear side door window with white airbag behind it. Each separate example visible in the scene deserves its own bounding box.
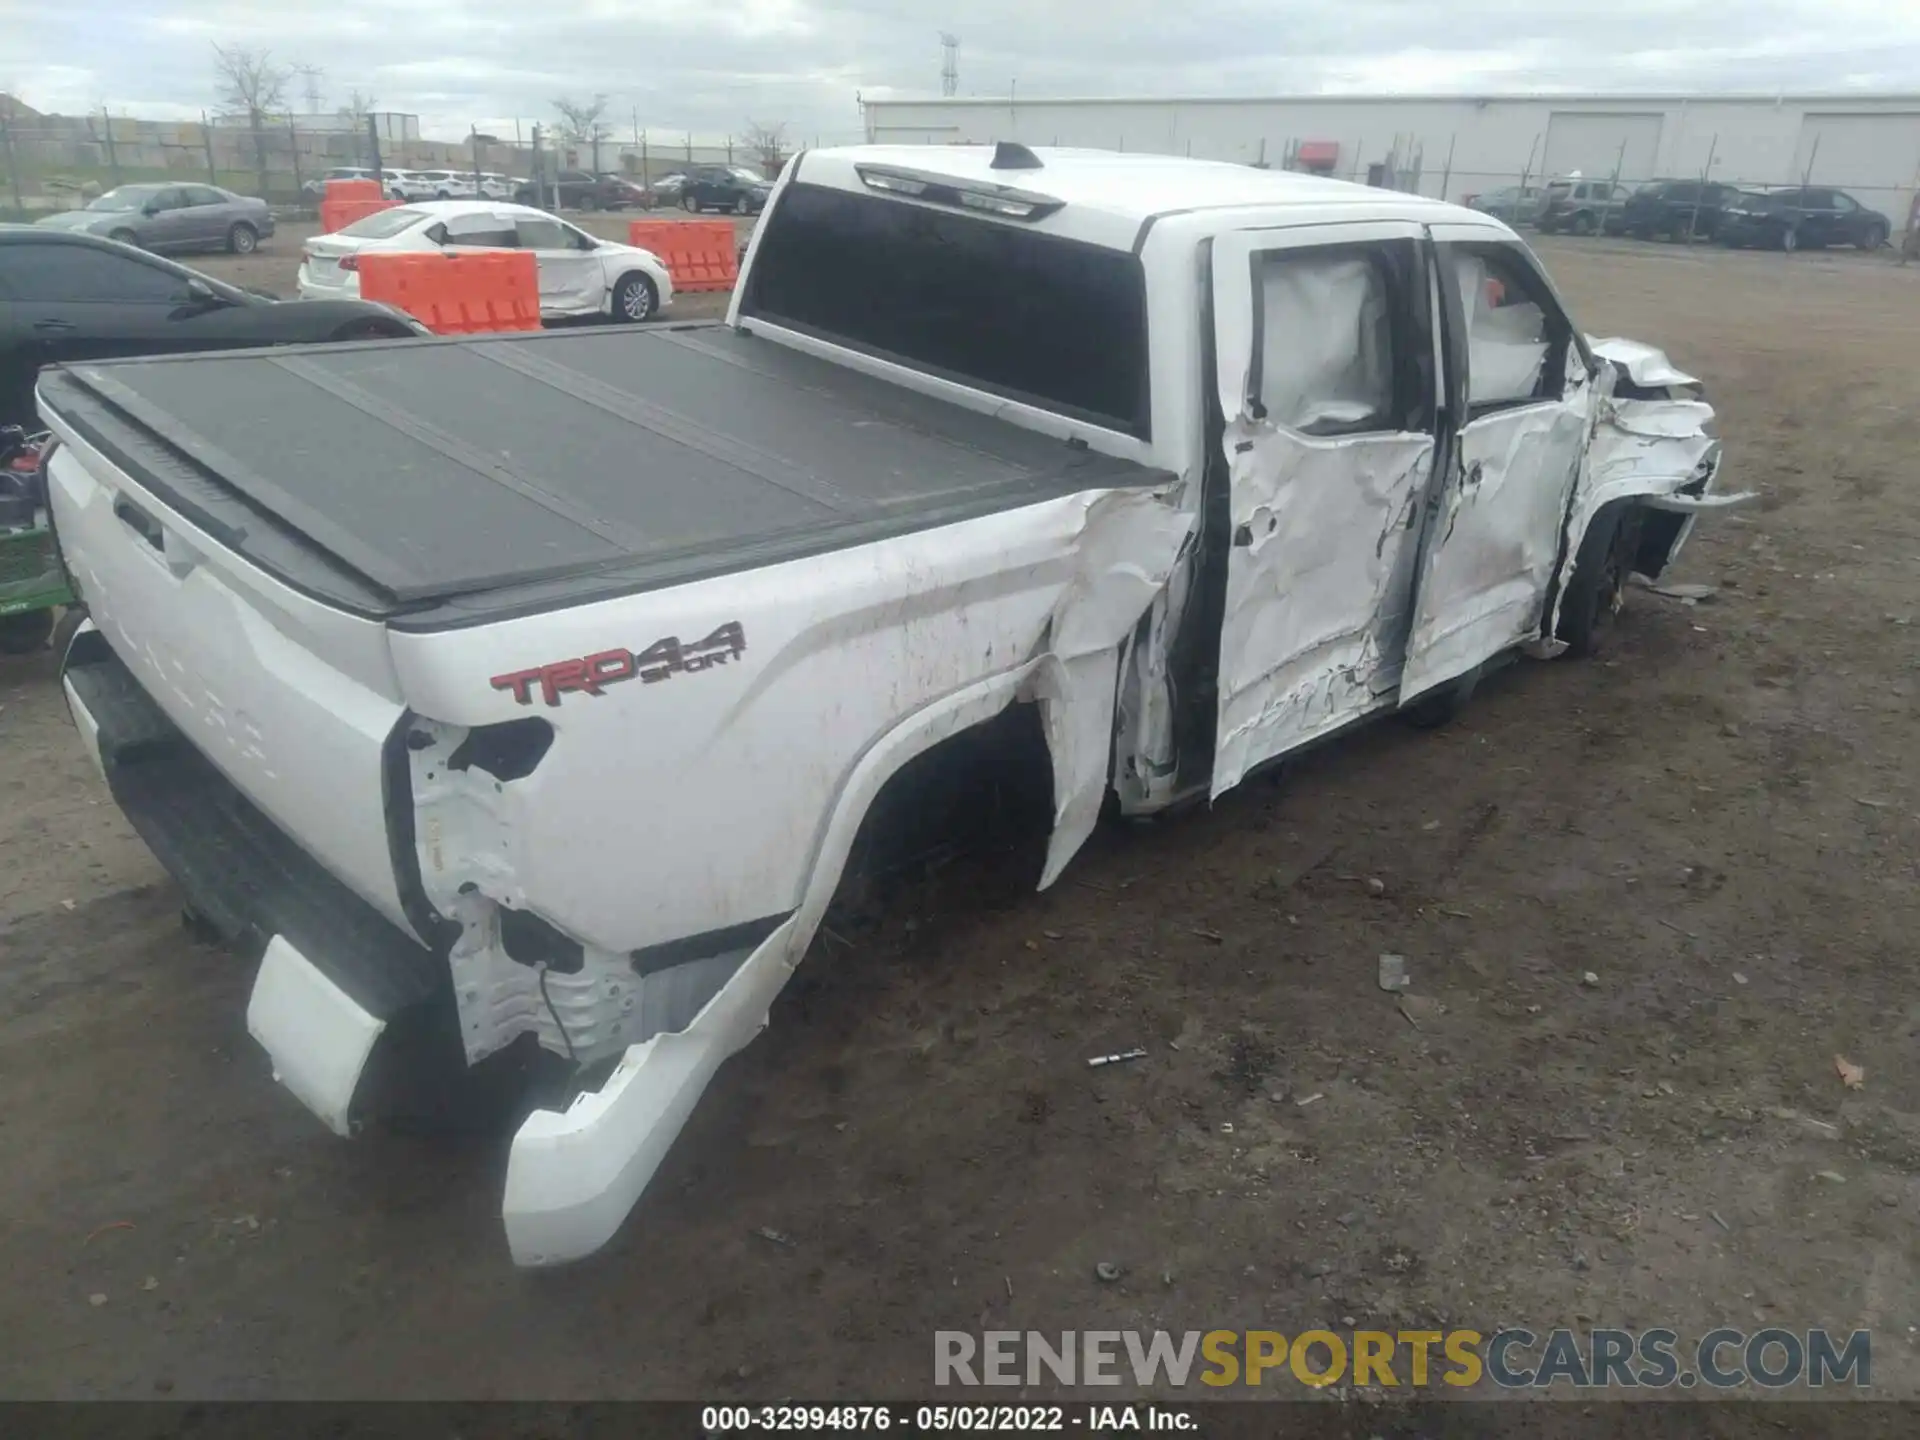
[1248,240,1432,436]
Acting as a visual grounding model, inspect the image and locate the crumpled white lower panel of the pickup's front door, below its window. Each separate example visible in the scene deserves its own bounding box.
[1400,401,1590,703]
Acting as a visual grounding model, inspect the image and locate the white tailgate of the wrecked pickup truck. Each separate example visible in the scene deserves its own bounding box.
[48,439,407,927]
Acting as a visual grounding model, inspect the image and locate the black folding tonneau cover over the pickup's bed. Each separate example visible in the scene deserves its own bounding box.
[40,324,1169,626]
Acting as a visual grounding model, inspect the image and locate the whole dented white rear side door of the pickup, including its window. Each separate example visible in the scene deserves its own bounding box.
[1212,221,1438,795]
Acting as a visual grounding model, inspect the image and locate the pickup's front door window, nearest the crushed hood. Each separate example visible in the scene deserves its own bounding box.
[1450,244,1572,417]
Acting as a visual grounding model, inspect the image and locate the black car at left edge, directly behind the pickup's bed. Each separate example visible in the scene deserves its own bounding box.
[0,225,426,424]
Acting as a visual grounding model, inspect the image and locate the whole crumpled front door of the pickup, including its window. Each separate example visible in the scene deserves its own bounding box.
[1400,225,1599,703]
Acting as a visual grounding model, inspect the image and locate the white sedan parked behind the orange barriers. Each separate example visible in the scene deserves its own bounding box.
[288,200,674,321]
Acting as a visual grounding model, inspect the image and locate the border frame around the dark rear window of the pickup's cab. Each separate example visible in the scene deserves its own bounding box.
[741,180,1154,442]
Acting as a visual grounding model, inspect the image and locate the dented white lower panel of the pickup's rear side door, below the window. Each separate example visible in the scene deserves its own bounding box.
[1212,420,1434,797]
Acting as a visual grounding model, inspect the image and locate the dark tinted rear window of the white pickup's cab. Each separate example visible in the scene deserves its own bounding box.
[741,184,1148,438]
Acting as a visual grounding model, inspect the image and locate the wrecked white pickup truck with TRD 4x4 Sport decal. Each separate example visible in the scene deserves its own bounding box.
[40,144,1738,1265]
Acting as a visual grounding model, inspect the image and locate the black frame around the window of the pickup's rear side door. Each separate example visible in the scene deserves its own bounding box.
[1242,236,1436,440]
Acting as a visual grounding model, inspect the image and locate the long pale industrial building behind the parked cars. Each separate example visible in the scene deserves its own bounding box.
[862,94,1920,228]
